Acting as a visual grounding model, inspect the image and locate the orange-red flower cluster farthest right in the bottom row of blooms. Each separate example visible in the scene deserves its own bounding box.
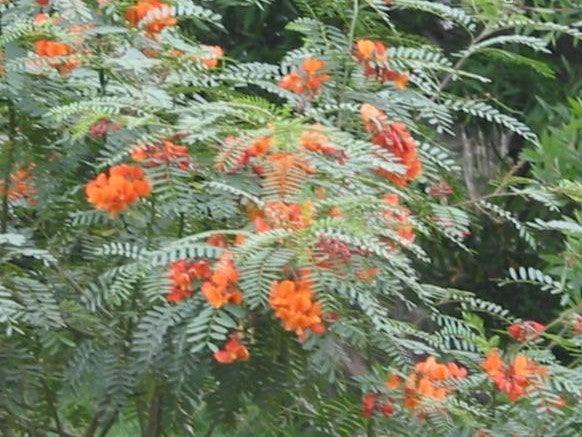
[481,349,548,402]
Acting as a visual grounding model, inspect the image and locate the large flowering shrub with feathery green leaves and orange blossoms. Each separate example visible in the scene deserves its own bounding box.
[0,0,582,437]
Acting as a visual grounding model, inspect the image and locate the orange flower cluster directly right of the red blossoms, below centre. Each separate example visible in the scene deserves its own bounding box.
[202,252,243,308]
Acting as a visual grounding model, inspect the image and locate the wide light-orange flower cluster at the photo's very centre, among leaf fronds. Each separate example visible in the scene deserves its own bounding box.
[253,200,315,232]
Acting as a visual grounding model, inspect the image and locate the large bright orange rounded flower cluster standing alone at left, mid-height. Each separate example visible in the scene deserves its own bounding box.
[85,164,152,216]
